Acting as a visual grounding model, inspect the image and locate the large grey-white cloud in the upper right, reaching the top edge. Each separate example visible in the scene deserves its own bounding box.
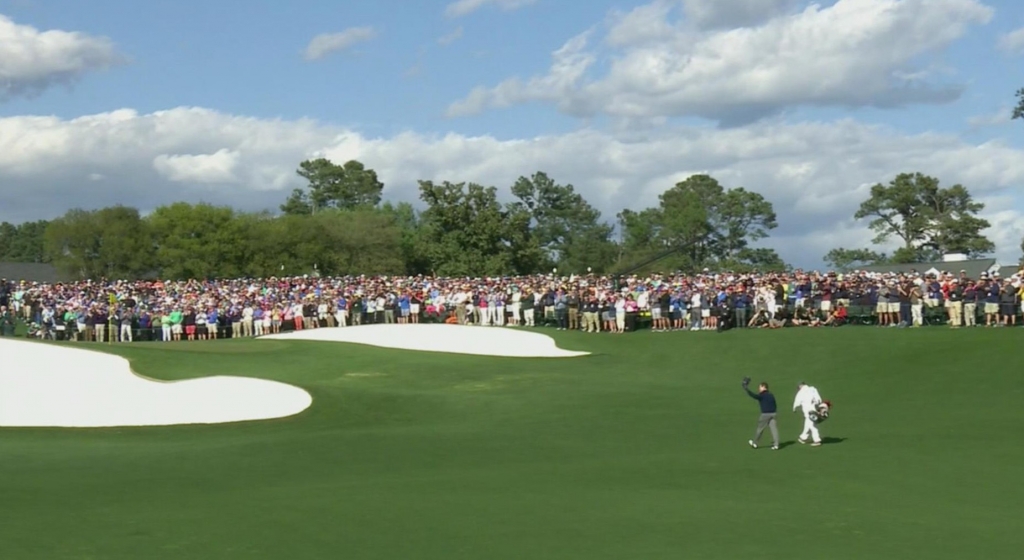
[447,0,992,124]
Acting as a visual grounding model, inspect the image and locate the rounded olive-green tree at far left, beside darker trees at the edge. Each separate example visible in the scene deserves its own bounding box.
[44,206,153,278]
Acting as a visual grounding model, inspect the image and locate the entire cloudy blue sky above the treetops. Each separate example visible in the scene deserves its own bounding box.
[0,0,1024,267]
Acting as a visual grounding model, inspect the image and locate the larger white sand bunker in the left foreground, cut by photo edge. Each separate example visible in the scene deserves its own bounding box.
[0,339,312,428]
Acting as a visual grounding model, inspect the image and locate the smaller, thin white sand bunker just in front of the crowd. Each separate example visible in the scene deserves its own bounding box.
[261,324,588,357]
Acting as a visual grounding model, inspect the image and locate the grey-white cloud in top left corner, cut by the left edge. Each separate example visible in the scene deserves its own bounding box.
[0,14,126,101]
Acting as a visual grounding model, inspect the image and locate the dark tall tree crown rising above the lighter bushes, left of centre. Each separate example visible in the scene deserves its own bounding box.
[281,158,384,214]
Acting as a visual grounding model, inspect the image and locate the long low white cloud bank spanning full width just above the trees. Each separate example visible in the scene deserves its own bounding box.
[0,107,1024,265]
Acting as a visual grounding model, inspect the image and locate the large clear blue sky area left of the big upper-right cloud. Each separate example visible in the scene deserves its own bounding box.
[0,0,606,137]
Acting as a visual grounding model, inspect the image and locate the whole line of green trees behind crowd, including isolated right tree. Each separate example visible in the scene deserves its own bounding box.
[0,159,992,278]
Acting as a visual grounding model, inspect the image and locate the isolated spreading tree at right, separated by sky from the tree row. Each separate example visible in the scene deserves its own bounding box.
[854,173,995,262]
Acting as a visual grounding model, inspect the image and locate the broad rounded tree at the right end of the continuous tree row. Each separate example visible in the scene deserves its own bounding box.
[618,175,781,270]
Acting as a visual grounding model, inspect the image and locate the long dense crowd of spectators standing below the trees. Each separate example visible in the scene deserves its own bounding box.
[0,270,1024,342]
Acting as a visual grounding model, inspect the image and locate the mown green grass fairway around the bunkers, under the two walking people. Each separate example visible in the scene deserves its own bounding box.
[0,328,1024,560]
